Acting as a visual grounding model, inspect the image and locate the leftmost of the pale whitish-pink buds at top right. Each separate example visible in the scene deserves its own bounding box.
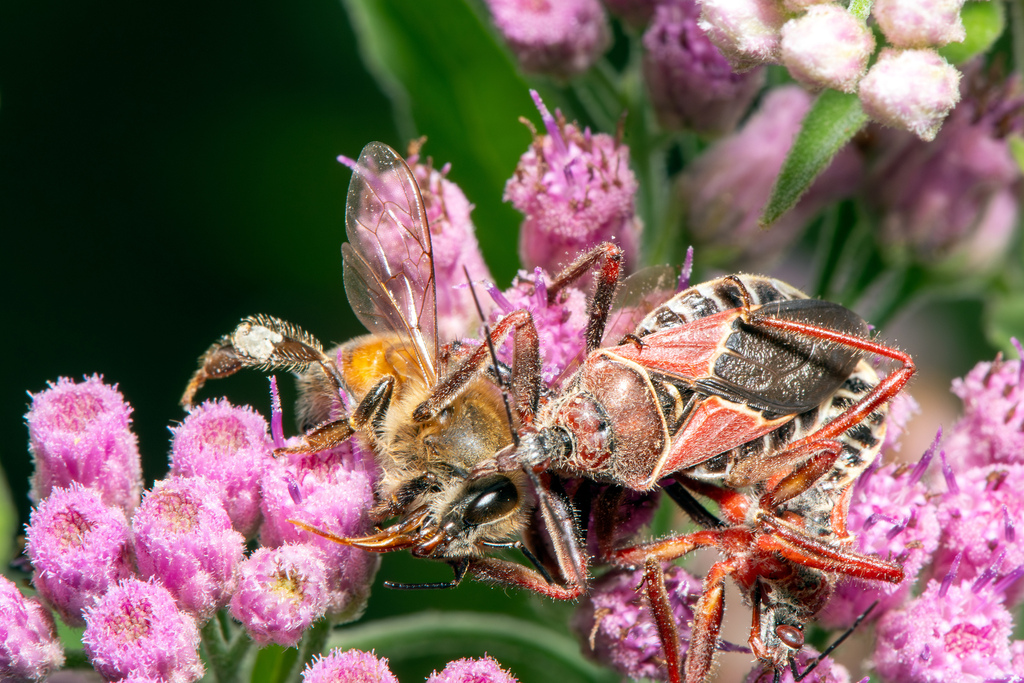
[700,0,786,71]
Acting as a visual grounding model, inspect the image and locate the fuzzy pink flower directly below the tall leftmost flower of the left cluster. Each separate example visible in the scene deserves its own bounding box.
[26,483,132,626]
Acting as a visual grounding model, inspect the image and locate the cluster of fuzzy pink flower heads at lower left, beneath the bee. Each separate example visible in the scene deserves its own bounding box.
[18,377,377,683]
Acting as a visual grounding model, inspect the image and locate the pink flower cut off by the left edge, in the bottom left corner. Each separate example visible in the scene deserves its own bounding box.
[0,577,65,683]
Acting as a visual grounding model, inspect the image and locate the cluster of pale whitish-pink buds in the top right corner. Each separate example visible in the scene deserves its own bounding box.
[700,0,964,140]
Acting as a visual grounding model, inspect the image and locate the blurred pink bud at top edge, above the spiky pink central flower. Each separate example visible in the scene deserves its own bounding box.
[486,0,611,78]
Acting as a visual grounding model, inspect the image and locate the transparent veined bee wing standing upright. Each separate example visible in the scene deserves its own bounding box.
[342,142,437,381]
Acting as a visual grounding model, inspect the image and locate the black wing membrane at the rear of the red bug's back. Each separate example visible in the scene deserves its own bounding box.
[695,299,867,417]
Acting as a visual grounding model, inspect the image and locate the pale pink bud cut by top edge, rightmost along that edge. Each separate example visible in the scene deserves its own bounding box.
[871,0,967,47]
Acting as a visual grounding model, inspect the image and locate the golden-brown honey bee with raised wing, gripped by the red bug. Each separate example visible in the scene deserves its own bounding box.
[181,142,586,599]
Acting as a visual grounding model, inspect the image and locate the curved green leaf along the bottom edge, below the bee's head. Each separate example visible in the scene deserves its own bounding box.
[325,611,620,683]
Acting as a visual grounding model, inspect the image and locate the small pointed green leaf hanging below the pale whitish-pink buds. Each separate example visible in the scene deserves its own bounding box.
[761,90,867,226]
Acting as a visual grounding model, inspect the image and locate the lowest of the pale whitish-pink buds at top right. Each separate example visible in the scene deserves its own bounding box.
[859,47,961,141]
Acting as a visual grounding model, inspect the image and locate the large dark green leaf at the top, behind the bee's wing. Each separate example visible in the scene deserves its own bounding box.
[344,0,536,281]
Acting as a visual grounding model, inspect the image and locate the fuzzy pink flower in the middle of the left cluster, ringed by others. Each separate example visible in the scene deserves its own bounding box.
[131,477,245,623]
